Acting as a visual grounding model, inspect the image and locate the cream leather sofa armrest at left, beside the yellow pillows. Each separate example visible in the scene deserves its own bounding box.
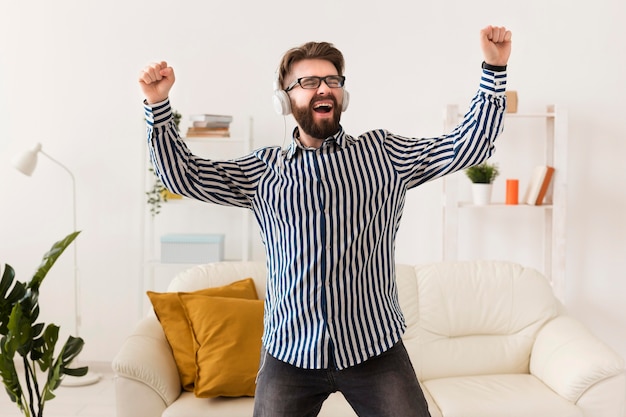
[112,315,182,416]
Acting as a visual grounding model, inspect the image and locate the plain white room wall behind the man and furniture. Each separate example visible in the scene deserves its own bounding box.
[0,0,626,368]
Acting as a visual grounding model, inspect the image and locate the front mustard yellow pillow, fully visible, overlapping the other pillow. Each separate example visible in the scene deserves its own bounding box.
[180,294,263,398]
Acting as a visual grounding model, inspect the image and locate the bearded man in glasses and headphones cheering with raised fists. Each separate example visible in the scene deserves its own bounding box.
[139,26,511,417]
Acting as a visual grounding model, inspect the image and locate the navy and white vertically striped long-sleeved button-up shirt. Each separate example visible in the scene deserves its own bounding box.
[145,69,506,369]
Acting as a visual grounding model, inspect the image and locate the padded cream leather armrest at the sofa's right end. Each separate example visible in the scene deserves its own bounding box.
[530,315,624,403]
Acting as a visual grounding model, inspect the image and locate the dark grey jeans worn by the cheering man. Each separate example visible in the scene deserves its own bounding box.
[254,341,430,417]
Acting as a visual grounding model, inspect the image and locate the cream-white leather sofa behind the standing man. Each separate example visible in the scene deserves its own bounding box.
[113,261,626,417]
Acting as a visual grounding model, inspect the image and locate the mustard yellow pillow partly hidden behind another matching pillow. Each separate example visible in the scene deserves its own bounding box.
[147,278,259,392]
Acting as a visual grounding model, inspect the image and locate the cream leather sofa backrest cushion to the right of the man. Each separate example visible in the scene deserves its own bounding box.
[398,261,558,380]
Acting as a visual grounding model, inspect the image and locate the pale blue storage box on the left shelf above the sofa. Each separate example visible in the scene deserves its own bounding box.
[161,234,224,264]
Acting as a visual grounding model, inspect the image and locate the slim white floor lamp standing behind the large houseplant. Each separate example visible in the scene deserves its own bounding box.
[13,143,101,386]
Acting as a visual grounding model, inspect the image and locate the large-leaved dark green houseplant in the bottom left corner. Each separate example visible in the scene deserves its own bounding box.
[0,232,88,417]
